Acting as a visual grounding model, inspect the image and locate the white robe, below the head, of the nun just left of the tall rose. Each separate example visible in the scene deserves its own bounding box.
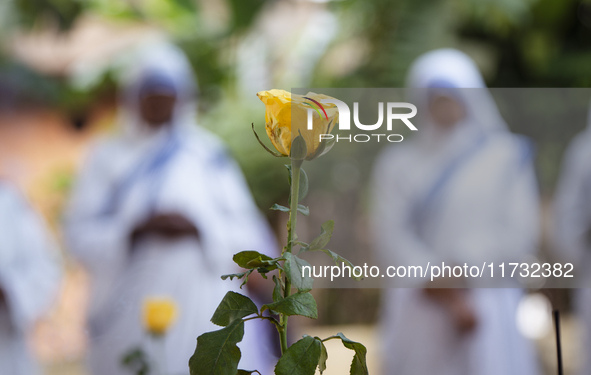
[66,129,274,375]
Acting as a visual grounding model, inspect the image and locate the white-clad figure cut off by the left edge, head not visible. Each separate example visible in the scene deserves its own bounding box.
[0,181,61,375]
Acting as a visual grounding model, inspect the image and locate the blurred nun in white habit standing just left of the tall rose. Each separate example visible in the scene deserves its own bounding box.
[65,44,274,375]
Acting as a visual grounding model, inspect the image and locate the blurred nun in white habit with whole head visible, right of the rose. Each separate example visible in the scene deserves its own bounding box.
[373,49,538,375]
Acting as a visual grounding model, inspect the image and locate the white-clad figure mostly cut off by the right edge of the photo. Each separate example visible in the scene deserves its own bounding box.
[553,102,591,374]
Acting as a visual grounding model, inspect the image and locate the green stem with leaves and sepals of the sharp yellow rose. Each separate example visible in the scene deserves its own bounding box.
[189,120,368,375]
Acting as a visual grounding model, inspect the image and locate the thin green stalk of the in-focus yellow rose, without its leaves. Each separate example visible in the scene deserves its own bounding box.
[279,159,303,354]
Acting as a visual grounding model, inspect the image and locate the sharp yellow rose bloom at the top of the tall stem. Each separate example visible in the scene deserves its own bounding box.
[257,90,338,160]
